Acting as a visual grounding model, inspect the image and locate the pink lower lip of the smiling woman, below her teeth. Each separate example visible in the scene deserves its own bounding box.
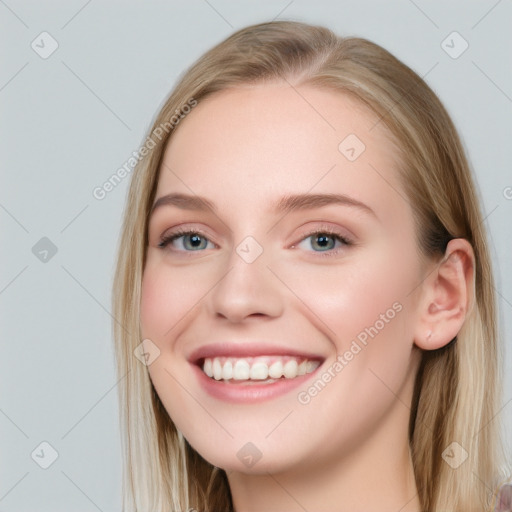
[192,364,322,403]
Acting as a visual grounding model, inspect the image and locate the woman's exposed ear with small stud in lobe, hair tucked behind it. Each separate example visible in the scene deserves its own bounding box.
[414,238,475,350]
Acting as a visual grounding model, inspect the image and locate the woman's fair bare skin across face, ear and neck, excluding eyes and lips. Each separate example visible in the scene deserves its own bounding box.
[140,82,473,512]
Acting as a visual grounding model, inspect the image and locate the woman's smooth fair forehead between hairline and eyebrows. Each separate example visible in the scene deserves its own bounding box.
[157,83,406,222]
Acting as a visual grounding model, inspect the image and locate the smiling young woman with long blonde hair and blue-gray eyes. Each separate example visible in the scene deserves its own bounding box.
[113,22,506,512]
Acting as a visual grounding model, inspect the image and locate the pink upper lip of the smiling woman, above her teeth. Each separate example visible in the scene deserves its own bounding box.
[187,342,325,364]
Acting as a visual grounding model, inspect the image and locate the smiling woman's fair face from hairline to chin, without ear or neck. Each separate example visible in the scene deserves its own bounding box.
[140,83,423,473]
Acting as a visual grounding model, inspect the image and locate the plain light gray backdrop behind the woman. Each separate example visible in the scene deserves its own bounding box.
[0,0,512,512]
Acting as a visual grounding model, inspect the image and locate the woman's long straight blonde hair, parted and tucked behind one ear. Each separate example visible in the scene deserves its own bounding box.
[113,21,505,512]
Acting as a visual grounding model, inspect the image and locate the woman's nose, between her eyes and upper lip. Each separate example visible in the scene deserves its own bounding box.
[208,240,284,323]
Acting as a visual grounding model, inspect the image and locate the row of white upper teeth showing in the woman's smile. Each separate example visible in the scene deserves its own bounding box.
[203,356,320,382]
